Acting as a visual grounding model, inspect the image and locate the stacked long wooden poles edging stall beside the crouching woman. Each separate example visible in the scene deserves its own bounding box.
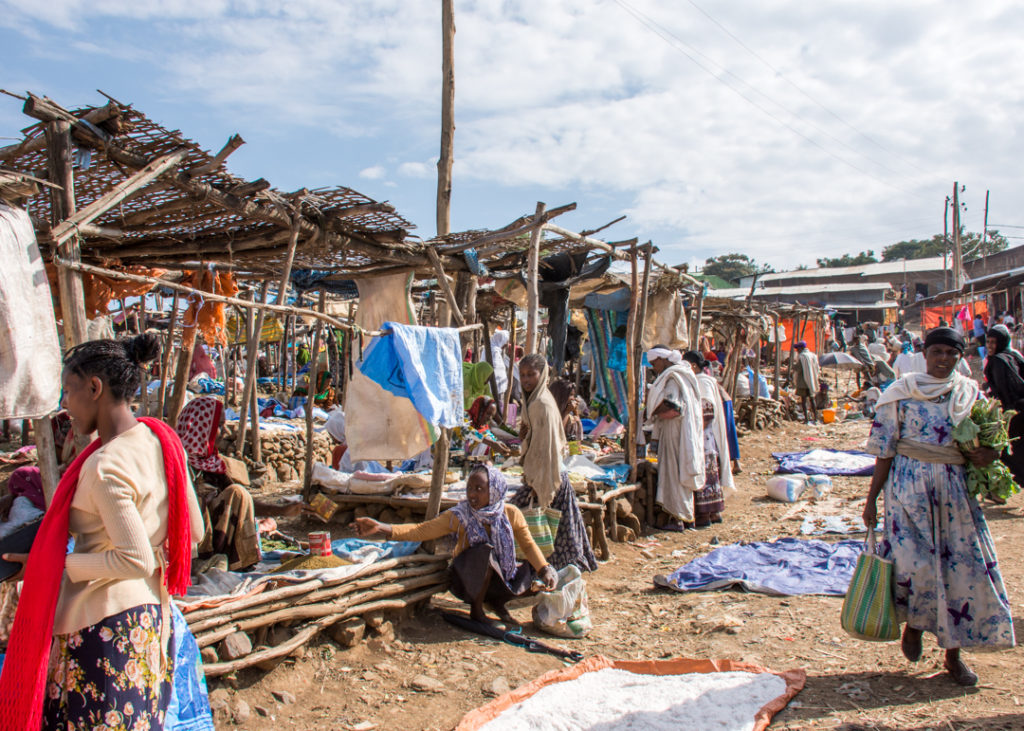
[179,553,451,677]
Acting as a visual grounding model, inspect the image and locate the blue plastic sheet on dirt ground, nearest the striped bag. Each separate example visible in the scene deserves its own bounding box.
[654,538,864,597]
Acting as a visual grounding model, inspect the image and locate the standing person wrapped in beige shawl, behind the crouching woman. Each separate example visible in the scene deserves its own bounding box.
[513,353,597,571]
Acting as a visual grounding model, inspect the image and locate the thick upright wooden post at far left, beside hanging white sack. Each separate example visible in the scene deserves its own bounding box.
[46,120,88,349]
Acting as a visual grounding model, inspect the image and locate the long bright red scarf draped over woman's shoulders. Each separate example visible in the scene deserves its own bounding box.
[0,418,191,731]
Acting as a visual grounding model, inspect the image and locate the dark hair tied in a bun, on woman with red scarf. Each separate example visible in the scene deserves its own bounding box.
[63,333,160,401]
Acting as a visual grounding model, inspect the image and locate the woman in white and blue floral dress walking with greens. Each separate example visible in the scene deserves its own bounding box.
[863,328,1014,686]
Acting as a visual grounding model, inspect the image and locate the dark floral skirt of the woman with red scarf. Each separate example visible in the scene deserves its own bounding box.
[43,604,173,731]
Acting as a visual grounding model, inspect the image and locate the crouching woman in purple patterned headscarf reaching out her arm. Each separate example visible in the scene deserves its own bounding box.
[353,465,558,625]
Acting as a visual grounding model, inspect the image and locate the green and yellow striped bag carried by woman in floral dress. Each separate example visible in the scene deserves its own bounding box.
[840,528,900,642]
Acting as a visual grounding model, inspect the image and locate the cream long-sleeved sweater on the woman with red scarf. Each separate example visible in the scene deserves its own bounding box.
[53,423,204,635]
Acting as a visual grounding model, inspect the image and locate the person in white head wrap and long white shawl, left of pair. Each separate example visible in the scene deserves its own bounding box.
[646,345,705,527]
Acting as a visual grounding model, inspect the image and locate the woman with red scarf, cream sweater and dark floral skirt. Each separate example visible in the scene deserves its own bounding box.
[0,335,203,731]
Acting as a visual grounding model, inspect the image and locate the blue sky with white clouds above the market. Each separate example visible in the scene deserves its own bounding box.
[0,0,1024,268]
